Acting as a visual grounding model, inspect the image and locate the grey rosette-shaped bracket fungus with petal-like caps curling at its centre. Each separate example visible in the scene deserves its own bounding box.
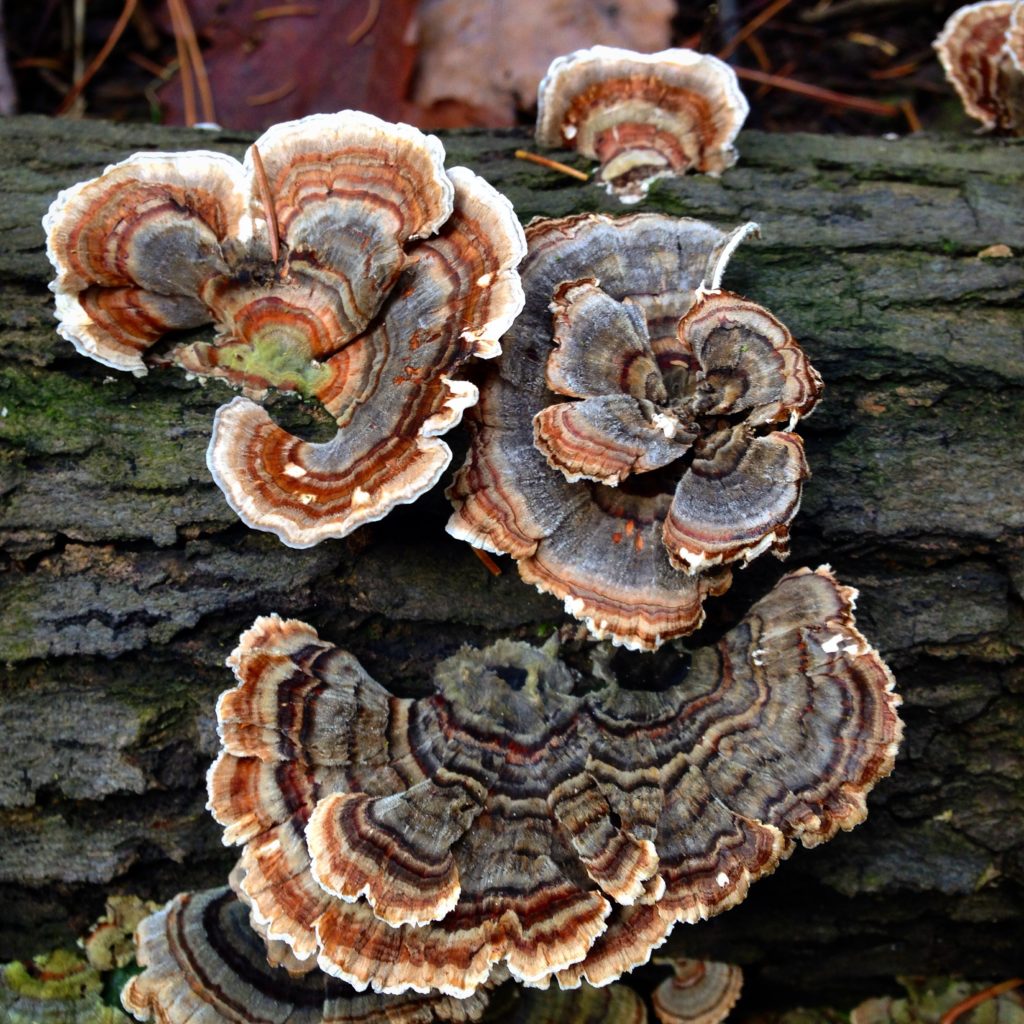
[447,214,821,649]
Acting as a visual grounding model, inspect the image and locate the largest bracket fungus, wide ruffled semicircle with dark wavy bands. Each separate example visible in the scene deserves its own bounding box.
[209,569,900,996]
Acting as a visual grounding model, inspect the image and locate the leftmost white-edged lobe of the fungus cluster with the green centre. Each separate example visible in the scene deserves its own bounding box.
[43,152,253,375]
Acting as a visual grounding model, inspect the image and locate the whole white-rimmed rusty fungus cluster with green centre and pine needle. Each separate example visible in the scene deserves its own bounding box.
[43,111,524,548]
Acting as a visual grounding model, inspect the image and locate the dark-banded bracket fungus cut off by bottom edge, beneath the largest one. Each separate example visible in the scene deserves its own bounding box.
[121,888,487,1024]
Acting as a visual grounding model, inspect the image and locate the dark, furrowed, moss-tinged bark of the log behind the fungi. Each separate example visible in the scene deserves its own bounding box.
[0,118,1024,1000]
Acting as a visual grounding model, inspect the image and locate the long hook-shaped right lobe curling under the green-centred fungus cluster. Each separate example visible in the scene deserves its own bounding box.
[207,168,524,548]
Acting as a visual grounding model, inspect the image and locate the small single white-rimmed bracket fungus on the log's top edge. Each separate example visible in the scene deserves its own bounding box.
[537,46,750,203]
